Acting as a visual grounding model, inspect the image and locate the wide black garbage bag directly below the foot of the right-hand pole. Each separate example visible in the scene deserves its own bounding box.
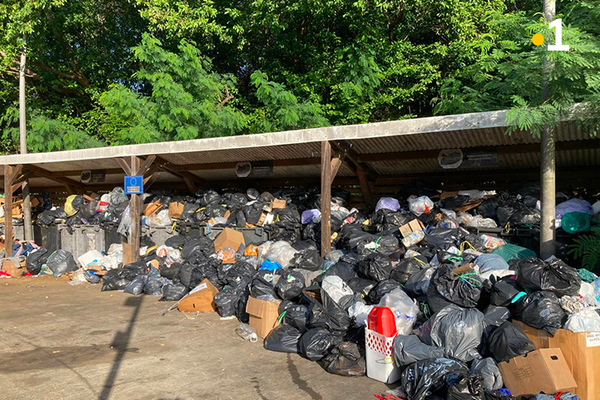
[517,257,581,297]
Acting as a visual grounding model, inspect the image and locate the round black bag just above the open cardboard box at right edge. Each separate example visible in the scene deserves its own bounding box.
[518,291,567,335]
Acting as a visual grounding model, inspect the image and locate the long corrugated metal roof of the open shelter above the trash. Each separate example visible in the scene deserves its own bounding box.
[0,111,600,187]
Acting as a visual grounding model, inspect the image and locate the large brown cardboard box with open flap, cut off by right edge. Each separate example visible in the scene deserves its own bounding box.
[514,321,600,400]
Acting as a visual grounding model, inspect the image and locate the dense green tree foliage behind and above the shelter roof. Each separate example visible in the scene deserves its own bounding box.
[0,0,600,152]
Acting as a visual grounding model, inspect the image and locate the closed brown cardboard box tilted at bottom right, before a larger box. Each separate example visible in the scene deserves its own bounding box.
[498,349,577,397]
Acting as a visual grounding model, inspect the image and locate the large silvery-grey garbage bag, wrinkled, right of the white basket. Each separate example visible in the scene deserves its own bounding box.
[416,304,484,362]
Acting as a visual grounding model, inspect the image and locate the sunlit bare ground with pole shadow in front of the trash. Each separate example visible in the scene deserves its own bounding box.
[0,277,387,400]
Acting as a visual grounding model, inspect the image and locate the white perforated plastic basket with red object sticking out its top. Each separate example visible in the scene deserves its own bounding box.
[365,328,400,383]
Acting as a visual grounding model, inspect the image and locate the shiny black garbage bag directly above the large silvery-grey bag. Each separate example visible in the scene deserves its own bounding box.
[427,265,483,312]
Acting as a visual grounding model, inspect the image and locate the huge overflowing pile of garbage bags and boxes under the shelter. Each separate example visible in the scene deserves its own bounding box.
[5,185,600,400]
